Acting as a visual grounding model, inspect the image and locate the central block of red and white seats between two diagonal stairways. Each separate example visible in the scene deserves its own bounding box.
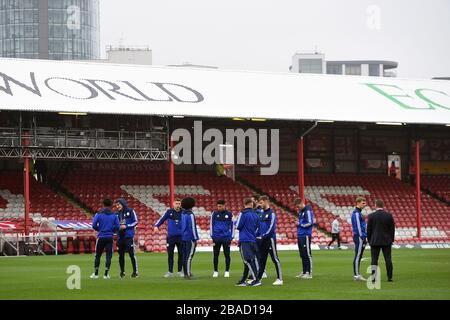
[63,169,329,252]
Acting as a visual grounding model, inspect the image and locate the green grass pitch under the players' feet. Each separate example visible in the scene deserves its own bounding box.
[0,249,450,300]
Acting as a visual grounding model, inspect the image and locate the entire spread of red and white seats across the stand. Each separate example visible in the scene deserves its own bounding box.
[0,166,450,253]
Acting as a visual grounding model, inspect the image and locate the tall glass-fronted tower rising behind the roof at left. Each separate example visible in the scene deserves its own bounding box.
[0,0,100,60]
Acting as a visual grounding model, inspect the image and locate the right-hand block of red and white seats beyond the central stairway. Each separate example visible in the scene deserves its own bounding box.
[241,174,450,243]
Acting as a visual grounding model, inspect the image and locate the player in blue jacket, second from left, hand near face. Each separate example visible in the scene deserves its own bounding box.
[116,198,139,278]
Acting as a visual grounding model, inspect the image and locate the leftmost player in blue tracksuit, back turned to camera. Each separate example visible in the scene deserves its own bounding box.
[91,199,119,279]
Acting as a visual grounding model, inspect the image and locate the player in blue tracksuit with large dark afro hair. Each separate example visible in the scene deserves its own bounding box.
[181,197,199,279]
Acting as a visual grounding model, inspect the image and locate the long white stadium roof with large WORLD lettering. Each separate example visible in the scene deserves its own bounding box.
[0,59,450,124]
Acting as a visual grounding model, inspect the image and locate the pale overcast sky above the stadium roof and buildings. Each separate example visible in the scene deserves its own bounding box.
[100,0,450,78]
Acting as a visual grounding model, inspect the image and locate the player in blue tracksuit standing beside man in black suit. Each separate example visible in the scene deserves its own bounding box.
[352,197,367,281]
